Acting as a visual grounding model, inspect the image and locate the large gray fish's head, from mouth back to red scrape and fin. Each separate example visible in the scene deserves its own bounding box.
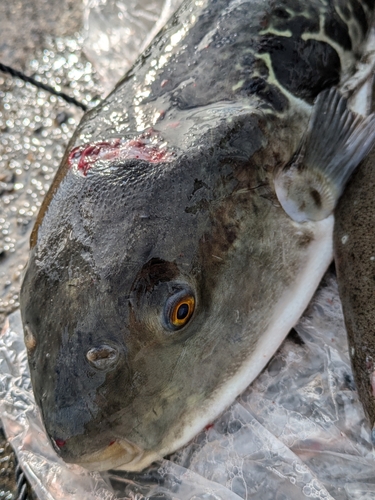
[21,111,331,470]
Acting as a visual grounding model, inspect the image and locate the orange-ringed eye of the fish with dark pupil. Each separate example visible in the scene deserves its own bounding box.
[164,290,195,330]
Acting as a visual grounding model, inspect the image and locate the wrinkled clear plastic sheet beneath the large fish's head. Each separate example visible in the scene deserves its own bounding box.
[0,275,375,500]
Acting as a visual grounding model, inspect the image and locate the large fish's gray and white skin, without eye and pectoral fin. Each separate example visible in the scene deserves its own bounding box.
[21,0,373,470]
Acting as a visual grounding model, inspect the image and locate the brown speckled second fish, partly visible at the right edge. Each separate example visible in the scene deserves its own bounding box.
[334,146,375,426]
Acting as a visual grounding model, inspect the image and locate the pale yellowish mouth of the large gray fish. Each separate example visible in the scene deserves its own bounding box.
[73,440,145,471]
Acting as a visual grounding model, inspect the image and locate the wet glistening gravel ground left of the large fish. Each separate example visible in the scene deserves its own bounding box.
[0,0,99,500]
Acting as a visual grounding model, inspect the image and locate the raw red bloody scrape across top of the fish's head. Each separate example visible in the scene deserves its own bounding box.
[68,138,170,176]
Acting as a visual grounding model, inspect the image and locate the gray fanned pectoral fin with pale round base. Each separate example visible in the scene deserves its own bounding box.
[275,89,375,222]
